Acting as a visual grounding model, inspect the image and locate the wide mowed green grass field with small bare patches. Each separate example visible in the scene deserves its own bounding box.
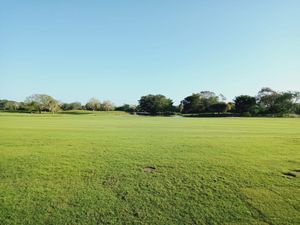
[0,113,300,225]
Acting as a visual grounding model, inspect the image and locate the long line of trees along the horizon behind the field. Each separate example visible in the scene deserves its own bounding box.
[0,87,300,116]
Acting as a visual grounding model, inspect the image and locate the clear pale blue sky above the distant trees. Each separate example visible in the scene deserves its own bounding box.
[0,0,300,104]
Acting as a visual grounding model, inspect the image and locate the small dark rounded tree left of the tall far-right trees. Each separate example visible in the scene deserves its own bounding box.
[234,95,256,113]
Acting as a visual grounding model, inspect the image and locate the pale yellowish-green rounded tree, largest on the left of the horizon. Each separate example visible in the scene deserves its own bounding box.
[25,94,59,113]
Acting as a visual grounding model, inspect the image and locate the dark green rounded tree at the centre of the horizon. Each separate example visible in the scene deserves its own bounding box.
[138,95,173,115]
